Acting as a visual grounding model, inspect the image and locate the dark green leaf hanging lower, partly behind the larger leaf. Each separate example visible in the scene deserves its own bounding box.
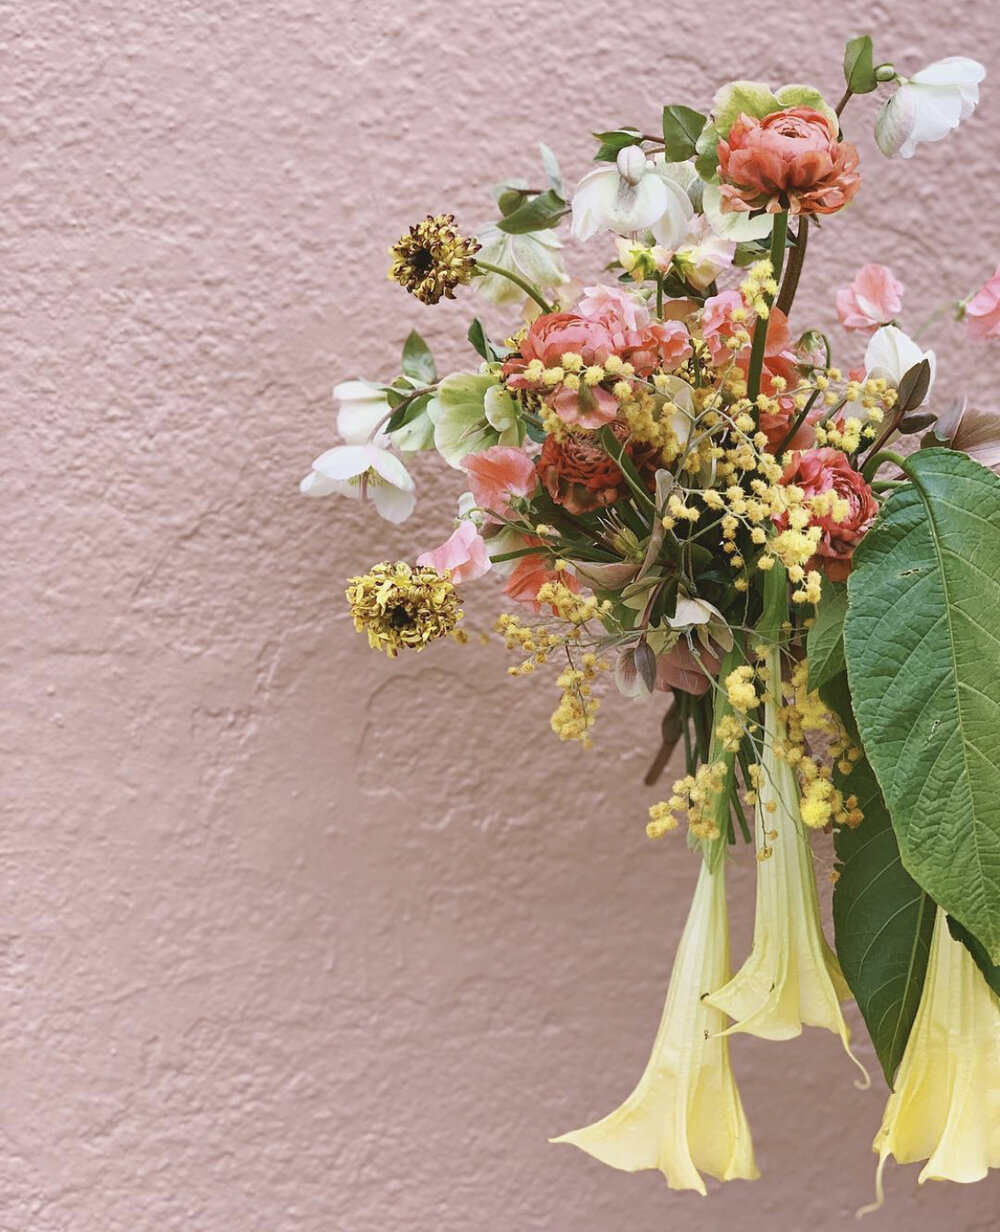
[834,760,935,1087]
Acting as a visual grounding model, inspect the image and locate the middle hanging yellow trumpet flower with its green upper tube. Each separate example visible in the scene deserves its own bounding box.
[708,565,867,1079]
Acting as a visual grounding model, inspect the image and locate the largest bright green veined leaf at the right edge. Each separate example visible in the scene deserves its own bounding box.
[844,450,1000,962]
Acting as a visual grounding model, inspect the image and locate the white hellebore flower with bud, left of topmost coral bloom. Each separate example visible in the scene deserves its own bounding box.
[573,145,695,249]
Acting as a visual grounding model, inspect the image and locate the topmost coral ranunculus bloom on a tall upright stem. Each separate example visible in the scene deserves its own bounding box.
[718,107,861,214]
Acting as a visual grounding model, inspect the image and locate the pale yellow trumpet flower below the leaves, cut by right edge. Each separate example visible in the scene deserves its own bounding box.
[858,907,1000,1215]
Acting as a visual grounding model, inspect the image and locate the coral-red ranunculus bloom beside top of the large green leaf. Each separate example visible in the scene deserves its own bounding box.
[775,448,878,582]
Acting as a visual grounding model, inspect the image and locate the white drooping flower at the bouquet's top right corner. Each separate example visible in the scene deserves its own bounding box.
[876,55,986,158]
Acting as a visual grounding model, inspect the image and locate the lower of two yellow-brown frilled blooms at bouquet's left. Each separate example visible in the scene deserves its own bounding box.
[347,561,462,659]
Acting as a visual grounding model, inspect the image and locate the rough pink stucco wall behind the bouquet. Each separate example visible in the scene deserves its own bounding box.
[0,0,1000,1232]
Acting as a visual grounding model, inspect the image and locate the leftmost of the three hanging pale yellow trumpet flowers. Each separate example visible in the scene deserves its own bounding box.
[553,860,760,1195]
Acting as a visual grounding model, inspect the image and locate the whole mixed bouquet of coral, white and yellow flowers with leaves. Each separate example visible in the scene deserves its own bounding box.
[302,37,1000,1200]
